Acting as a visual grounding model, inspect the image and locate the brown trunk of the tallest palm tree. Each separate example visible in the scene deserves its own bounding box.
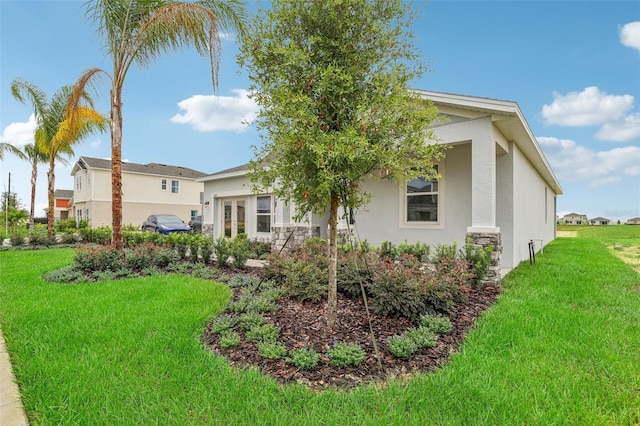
[111,90,124,250]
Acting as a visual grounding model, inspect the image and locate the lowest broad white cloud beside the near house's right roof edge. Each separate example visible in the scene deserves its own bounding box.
[536,137,640,187]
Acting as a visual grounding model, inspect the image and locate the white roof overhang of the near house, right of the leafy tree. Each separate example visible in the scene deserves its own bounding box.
[415,90,562,195]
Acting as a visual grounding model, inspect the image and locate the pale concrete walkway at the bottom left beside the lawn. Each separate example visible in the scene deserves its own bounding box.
[0,324,29,426]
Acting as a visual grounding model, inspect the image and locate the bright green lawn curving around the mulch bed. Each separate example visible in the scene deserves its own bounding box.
[0,227,640,425]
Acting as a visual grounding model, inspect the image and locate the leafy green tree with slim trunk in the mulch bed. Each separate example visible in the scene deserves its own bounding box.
[239,0,445,330]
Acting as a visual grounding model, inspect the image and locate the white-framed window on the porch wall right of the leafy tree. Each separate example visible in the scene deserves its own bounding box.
[400,166,443,228]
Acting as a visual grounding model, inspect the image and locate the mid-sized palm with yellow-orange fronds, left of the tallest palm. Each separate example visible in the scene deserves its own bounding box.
[11,79,108,238]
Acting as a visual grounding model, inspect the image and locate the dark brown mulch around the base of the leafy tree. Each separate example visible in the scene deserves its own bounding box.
[202,278,501,390]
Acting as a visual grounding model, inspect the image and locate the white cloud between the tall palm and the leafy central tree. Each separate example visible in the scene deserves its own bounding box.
[171,89,258,133]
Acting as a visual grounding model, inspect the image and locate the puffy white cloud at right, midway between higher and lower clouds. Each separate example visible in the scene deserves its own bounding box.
[542,86,633,127]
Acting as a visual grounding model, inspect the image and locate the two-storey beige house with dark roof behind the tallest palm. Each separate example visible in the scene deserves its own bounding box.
[71,157,206,228]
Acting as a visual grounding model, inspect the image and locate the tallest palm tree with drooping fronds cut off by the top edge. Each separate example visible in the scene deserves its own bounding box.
[74,0,247,248]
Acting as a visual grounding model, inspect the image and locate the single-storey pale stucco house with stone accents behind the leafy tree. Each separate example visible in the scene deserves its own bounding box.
[197,91,562,279]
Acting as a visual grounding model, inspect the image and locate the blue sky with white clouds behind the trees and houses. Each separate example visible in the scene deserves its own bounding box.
[0,0,640,221]
